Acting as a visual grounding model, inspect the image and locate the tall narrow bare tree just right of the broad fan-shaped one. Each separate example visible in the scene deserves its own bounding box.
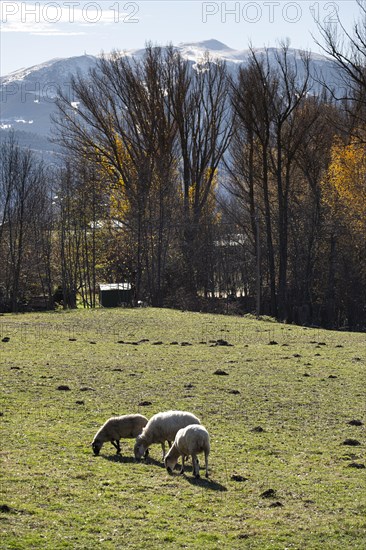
[167,48,232,295]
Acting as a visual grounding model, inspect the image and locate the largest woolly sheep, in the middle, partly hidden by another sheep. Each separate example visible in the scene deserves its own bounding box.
[134,411,201,460]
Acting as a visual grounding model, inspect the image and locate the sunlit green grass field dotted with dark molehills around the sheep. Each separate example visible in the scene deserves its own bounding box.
[0,308,366,550]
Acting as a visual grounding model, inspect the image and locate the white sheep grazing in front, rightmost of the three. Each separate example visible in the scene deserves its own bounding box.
[164,425,210,478]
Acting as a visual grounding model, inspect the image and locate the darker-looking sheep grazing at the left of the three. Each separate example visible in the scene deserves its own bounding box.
[92,414,147,456]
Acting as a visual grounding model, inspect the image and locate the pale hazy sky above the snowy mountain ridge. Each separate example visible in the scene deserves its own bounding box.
[0,0,358,75]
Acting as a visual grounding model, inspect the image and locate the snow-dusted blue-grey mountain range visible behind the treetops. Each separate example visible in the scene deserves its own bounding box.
[0,39,339,162]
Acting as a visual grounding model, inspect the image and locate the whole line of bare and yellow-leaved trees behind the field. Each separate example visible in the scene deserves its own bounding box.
[0,5,366,328]
